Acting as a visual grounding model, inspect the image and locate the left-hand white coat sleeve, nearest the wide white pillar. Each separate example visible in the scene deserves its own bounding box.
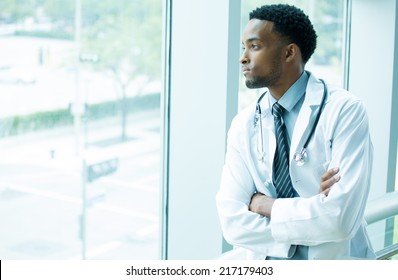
[216,114,290,257]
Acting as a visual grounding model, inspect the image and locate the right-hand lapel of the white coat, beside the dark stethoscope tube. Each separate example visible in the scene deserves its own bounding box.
[290,73,323,162]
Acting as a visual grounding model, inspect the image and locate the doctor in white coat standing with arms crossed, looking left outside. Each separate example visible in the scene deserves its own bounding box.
[217,5,375,259]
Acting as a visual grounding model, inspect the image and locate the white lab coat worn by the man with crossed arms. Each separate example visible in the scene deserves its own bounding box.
[217,73,375,259]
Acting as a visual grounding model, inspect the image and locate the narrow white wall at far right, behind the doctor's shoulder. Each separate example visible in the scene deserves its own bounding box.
[349,0,398,247]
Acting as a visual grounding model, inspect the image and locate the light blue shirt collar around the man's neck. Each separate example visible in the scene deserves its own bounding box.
[268,71,309,112]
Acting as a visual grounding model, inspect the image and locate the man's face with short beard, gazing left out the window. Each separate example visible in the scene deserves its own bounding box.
[240,19,284,88]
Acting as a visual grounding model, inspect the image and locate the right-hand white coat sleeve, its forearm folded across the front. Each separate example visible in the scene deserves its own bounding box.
[271,100,373,246]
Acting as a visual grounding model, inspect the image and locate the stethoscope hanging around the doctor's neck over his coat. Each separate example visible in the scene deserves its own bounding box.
[254,79,328,166]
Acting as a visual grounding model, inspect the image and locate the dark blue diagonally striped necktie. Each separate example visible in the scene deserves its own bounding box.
[272,102,294,198]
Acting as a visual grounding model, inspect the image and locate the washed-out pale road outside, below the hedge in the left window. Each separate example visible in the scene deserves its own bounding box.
[0,110,161,259]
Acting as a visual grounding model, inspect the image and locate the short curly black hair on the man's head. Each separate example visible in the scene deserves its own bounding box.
[249,4,317,63]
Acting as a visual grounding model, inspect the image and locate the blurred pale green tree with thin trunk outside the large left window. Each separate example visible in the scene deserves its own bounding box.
[82,0,162,140]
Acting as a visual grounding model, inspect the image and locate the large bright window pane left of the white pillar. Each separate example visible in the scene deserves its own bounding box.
[0,0,162,259]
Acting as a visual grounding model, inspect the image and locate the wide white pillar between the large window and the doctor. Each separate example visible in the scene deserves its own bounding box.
[164,0,240,259]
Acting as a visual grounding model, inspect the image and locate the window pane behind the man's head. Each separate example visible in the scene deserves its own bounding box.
[239,0,345,109]
